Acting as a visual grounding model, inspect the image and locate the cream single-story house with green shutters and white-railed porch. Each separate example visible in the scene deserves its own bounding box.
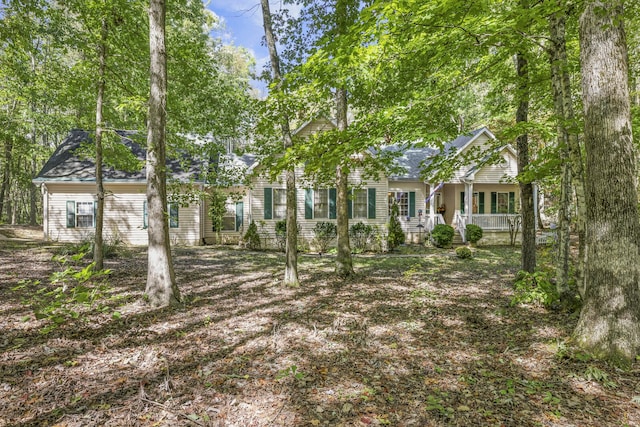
[33,119,519,245]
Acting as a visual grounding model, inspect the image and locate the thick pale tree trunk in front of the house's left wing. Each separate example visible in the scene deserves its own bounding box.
[145,0,180,307]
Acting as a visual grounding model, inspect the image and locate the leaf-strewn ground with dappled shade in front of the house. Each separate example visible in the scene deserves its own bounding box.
[0,230,640,427]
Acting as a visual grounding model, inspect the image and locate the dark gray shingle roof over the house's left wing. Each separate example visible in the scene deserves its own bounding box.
[34,129,202,182]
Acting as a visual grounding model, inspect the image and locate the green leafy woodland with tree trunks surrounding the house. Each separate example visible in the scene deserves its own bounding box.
[0,0,640,425]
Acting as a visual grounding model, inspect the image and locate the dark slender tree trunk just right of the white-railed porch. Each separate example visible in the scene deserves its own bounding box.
[516,53,536,273]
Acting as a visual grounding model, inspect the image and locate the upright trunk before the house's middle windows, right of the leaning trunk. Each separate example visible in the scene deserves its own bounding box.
[336,88,354,277]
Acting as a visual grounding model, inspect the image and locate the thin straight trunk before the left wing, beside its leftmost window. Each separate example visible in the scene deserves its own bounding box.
[93,18,108,271]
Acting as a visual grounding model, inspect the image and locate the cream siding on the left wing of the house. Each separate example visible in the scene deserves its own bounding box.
[45,183,200,245]
